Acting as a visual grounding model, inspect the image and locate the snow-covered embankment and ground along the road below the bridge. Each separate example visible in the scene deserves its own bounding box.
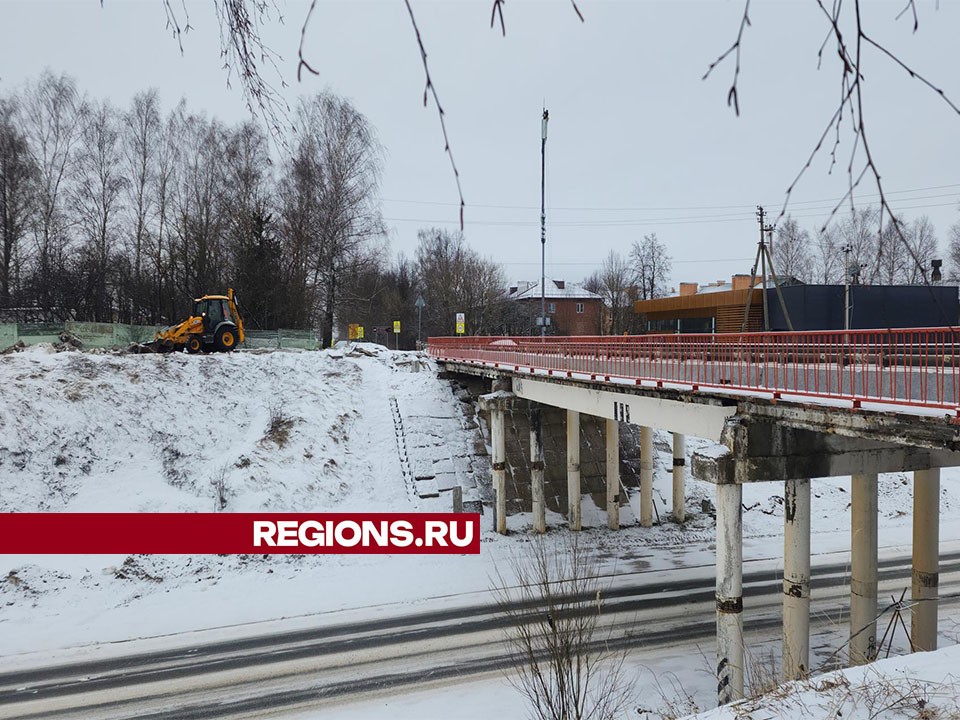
[0,346,960,718]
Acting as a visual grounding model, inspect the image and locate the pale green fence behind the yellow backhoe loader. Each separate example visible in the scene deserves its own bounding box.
[0,321,320,350]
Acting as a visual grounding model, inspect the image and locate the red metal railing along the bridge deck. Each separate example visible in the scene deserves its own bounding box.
[427,328,960,414]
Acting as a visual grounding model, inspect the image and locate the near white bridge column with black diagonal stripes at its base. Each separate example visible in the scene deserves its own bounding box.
[717,484,744,705]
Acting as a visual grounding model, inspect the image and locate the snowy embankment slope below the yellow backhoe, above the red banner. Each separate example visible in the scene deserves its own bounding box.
[0,348,438,512]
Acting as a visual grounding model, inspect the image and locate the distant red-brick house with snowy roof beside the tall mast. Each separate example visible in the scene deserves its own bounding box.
[507,280,603,335]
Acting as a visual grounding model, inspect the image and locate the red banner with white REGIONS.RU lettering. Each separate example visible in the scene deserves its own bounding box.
[0,513,480,555]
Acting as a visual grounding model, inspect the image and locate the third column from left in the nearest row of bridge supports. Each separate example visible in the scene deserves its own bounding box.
[850,473,877,665]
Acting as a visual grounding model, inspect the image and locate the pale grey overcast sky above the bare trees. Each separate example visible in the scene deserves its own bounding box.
[0,0,960,283]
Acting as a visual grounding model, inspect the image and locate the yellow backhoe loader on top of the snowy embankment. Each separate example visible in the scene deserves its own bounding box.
[143,288,245,353]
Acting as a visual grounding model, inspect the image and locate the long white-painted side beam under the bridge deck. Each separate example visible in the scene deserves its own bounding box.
[513,377,737,442]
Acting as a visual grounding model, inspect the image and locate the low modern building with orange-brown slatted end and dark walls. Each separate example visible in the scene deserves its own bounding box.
[633,275,960,333]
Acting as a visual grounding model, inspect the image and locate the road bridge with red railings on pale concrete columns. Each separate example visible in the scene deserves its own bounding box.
[428,328,960,704]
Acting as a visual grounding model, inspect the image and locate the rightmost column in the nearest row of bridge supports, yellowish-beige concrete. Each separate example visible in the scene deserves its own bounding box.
[910,468,940,651]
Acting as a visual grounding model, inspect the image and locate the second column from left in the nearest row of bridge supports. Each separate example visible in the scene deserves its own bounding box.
[783,480,810,680]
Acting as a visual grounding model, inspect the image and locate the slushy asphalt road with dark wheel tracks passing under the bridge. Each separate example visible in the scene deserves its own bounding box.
[0,553,960,720]
